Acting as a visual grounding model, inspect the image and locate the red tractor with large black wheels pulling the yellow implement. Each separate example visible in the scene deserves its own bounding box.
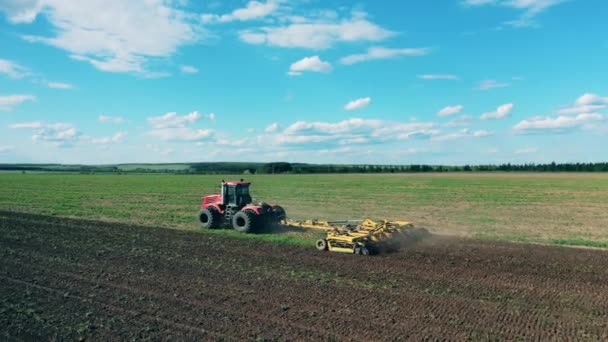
[198,179,286,233]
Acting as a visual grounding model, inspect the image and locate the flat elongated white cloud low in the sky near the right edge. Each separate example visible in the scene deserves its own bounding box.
[513,113,608,133]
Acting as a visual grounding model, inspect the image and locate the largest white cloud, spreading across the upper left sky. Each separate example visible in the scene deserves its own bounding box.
[7,0,203,74]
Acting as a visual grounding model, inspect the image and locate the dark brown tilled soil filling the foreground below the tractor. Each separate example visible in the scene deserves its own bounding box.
[0,212,608,341]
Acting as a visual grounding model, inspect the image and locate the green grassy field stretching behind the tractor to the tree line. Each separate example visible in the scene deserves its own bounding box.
[0,173,608,247]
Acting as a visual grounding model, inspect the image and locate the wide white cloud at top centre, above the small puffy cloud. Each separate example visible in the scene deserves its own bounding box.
[239,12,394,49]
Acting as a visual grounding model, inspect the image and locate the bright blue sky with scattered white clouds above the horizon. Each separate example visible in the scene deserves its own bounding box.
[0,0,608,164]
